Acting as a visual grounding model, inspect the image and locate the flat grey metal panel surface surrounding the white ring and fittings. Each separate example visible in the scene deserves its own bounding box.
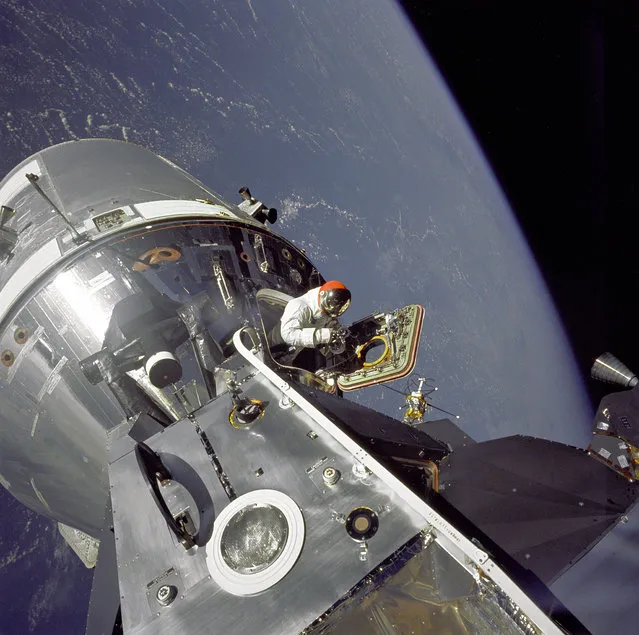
[110,376,424,635]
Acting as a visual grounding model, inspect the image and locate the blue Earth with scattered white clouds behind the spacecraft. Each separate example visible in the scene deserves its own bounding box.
[0,0,639,635]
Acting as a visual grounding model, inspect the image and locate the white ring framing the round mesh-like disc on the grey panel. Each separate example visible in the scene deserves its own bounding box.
[206,489,305,596]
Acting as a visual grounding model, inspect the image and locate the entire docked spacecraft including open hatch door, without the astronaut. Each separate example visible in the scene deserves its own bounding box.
[0,140,639,635]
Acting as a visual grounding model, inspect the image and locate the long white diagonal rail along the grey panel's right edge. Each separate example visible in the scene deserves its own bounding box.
[233,329,562,635]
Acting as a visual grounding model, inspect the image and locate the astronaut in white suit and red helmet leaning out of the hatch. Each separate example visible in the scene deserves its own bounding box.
[271,280,351,367]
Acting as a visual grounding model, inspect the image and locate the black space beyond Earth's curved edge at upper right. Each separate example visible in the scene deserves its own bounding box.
[401,0,639,403]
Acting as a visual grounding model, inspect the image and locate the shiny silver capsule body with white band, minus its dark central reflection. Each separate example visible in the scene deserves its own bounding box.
[0,140,318,536]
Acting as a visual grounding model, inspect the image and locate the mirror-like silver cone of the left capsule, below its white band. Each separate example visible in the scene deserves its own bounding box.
[0,219,319,535]
